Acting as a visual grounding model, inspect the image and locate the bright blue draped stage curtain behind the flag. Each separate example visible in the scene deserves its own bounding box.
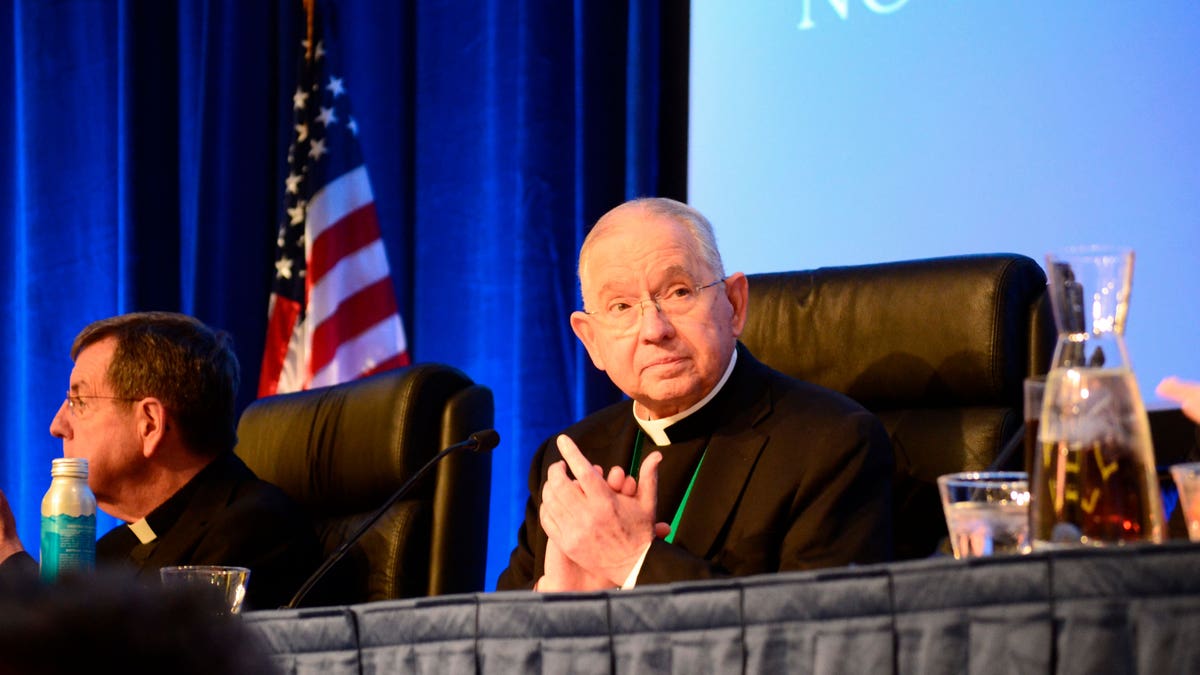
[0,0,688,587]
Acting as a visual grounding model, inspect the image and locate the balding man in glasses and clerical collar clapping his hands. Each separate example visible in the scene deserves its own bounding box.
[498,198,892,591]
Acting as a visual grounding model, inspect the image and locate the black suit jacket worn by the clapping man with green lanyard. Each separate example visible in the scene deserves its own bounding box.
[498,345,893,590]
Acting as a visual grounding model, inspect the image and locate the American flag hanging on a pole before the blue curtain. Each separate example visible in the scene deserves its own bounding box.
[258,2,408,396]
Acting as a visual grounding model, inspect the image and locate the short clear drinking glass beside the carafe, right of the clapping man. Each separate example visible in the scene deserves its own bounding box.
[937,471,1030,560]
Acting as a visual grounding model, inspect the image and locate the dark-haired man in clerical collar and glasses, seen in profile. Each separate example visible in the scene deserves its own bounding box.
[0,312,320,609]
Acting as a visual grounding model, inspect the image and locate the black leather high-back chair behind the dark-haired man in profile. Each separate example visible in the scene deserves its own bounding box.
[235,364,493,604]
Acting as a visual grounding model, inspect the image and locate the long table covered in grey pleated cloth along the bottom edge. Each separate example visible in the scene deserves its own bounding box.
[242,542,1200,675]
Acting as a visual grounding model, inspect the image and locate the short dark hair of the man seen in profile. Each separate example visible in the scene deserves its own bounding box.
[71,312,240,455]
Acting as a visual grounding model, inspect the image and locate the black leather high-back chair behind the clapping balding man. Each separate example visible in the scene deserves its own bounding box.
[742,255,1055,560]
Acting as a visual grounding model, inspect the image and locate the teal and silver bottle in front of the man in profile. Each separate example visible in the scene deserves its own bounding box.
[41,458,96,581]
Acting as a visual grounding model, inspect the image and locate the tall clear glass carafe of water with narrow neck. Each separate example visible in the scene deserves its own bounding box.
[1030,246,1164,549]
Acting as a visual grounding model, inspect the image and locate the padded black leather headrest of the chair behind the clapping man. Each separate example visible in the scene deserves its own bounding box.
[742,253,1046,410]
